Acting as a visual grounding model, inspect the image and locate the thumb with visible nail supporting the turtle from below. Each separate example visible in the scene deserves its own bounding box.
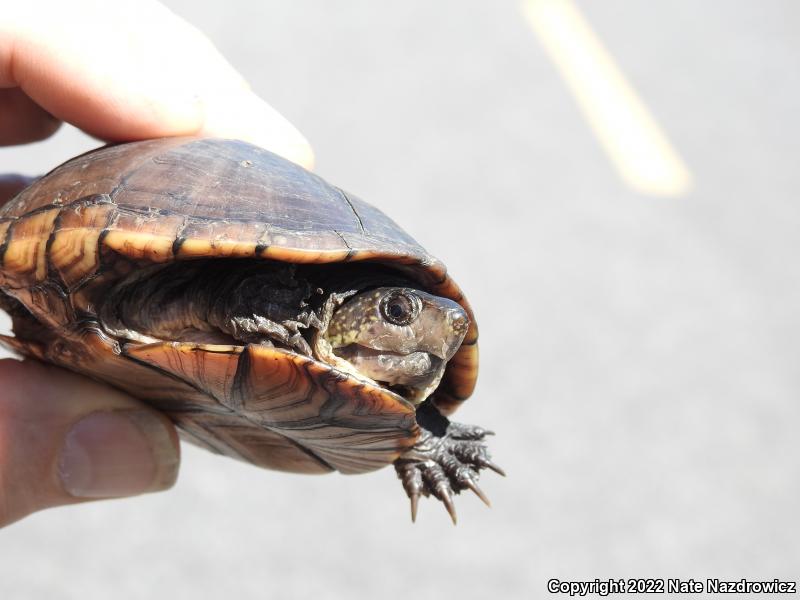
[0,359,179,526]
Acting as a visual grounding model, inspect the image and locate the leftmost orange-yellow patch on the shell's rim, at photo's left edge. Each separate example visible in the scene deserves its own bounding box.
[3,208,60,281]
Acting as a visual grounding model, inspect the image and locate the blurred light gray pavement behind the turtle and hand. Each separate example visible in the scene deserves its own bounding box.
[0,0,800,600]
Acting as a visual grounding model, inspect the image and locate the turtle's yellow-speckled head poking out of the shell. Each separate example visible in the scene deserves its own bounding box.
[325,287,469,402]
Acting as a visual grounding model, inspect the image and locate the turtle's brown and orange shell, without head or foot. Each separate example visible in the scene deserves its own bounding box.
[0,138,478,473]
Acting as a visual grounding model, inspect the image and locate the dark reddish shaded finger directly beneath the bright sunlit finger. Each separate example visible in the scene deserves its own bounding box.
[0,88,61,146]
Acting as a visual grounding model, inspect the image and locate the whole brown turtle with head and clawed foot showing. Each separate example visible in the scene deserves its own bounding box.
[0,137,504,523]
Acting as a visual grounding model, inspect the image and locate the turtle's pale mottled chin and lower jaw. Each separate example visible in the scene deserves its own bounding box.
[335,344,446,404]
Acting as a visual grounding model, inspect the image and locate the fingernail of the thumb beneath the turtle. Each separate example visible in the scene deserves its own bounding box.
[58,410,179,498]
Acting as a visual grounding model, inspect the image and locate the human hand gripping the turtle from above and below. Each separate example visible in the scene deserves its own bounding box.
[0,0,313,526]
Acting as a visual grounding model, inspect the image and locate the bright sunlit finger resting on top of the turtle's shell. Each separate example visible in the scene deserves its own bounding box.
[0,0,313,167]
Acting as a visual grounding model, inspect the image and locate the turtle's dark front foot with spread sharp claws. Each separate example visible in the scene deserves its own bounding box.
[394,402,505,525]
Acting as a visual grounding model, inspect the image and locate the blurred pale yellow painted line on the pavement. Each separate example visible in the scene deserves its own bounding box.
[522,0,692,196]
